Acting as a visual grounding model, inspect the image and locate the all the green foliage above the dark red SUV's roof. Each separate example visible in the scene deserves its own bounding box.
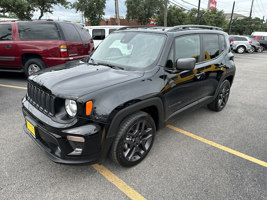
[0,0,69,20]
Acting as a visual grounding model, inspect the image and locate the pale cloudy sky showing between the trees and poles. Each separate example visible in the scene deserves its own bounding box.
[33,0,267,23]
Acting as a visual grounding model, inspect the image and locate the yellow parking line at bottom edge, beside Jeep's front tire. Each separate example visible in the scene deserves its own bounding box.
[92,164,145,200]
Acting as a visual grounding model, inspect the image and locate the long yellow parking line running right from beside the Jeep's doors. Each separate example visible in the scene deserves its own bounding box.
[167,124,267,167]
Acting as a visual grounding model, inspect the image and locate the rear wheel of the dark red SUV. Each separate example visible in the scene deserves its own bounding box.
[24,58,46,77]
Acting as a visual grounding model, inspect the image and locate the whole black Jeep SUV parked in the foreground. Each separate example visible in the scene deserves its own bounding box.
[22,25,235,166]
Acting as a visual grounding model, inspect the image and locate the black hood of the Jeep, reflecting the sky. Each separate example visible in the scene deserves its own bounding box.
[29,62,143,99]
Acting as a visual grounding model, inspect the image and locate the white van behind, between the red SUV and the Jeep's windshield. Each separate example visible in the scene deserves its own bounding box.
[84,26,125,48]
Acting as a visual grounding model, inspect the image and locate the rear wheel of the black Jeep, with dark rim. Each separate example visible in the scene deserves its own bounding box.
[208,80,231,112]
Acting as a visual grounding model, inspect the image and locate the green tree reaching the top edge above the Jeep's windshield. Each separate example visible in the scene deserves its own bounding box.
[125,0,164,25]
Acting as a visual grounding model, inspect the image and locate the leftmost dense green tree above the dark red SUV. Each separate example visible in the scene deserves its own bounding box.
[0,0,34,19]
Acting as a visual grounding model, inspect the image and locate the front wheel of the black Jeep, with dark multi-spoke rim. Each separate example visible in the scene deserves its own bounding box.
[110,111,156,167]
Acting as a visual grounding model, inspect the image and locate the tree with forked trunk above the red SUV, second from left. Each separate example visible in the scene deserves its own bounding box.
[28,0,69,19]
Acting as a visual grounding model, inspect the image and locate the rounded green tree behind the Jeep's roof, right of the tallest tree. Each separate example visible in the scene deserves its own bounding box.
[156,6,188,26]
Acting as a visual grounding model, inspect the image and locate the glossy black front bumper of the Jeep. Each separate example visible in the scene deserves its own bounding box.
[22,101,103,164]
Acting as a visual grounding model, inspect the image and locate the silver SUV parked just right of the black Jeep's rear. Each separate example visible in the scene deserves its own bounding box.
[229,35,252,53]
